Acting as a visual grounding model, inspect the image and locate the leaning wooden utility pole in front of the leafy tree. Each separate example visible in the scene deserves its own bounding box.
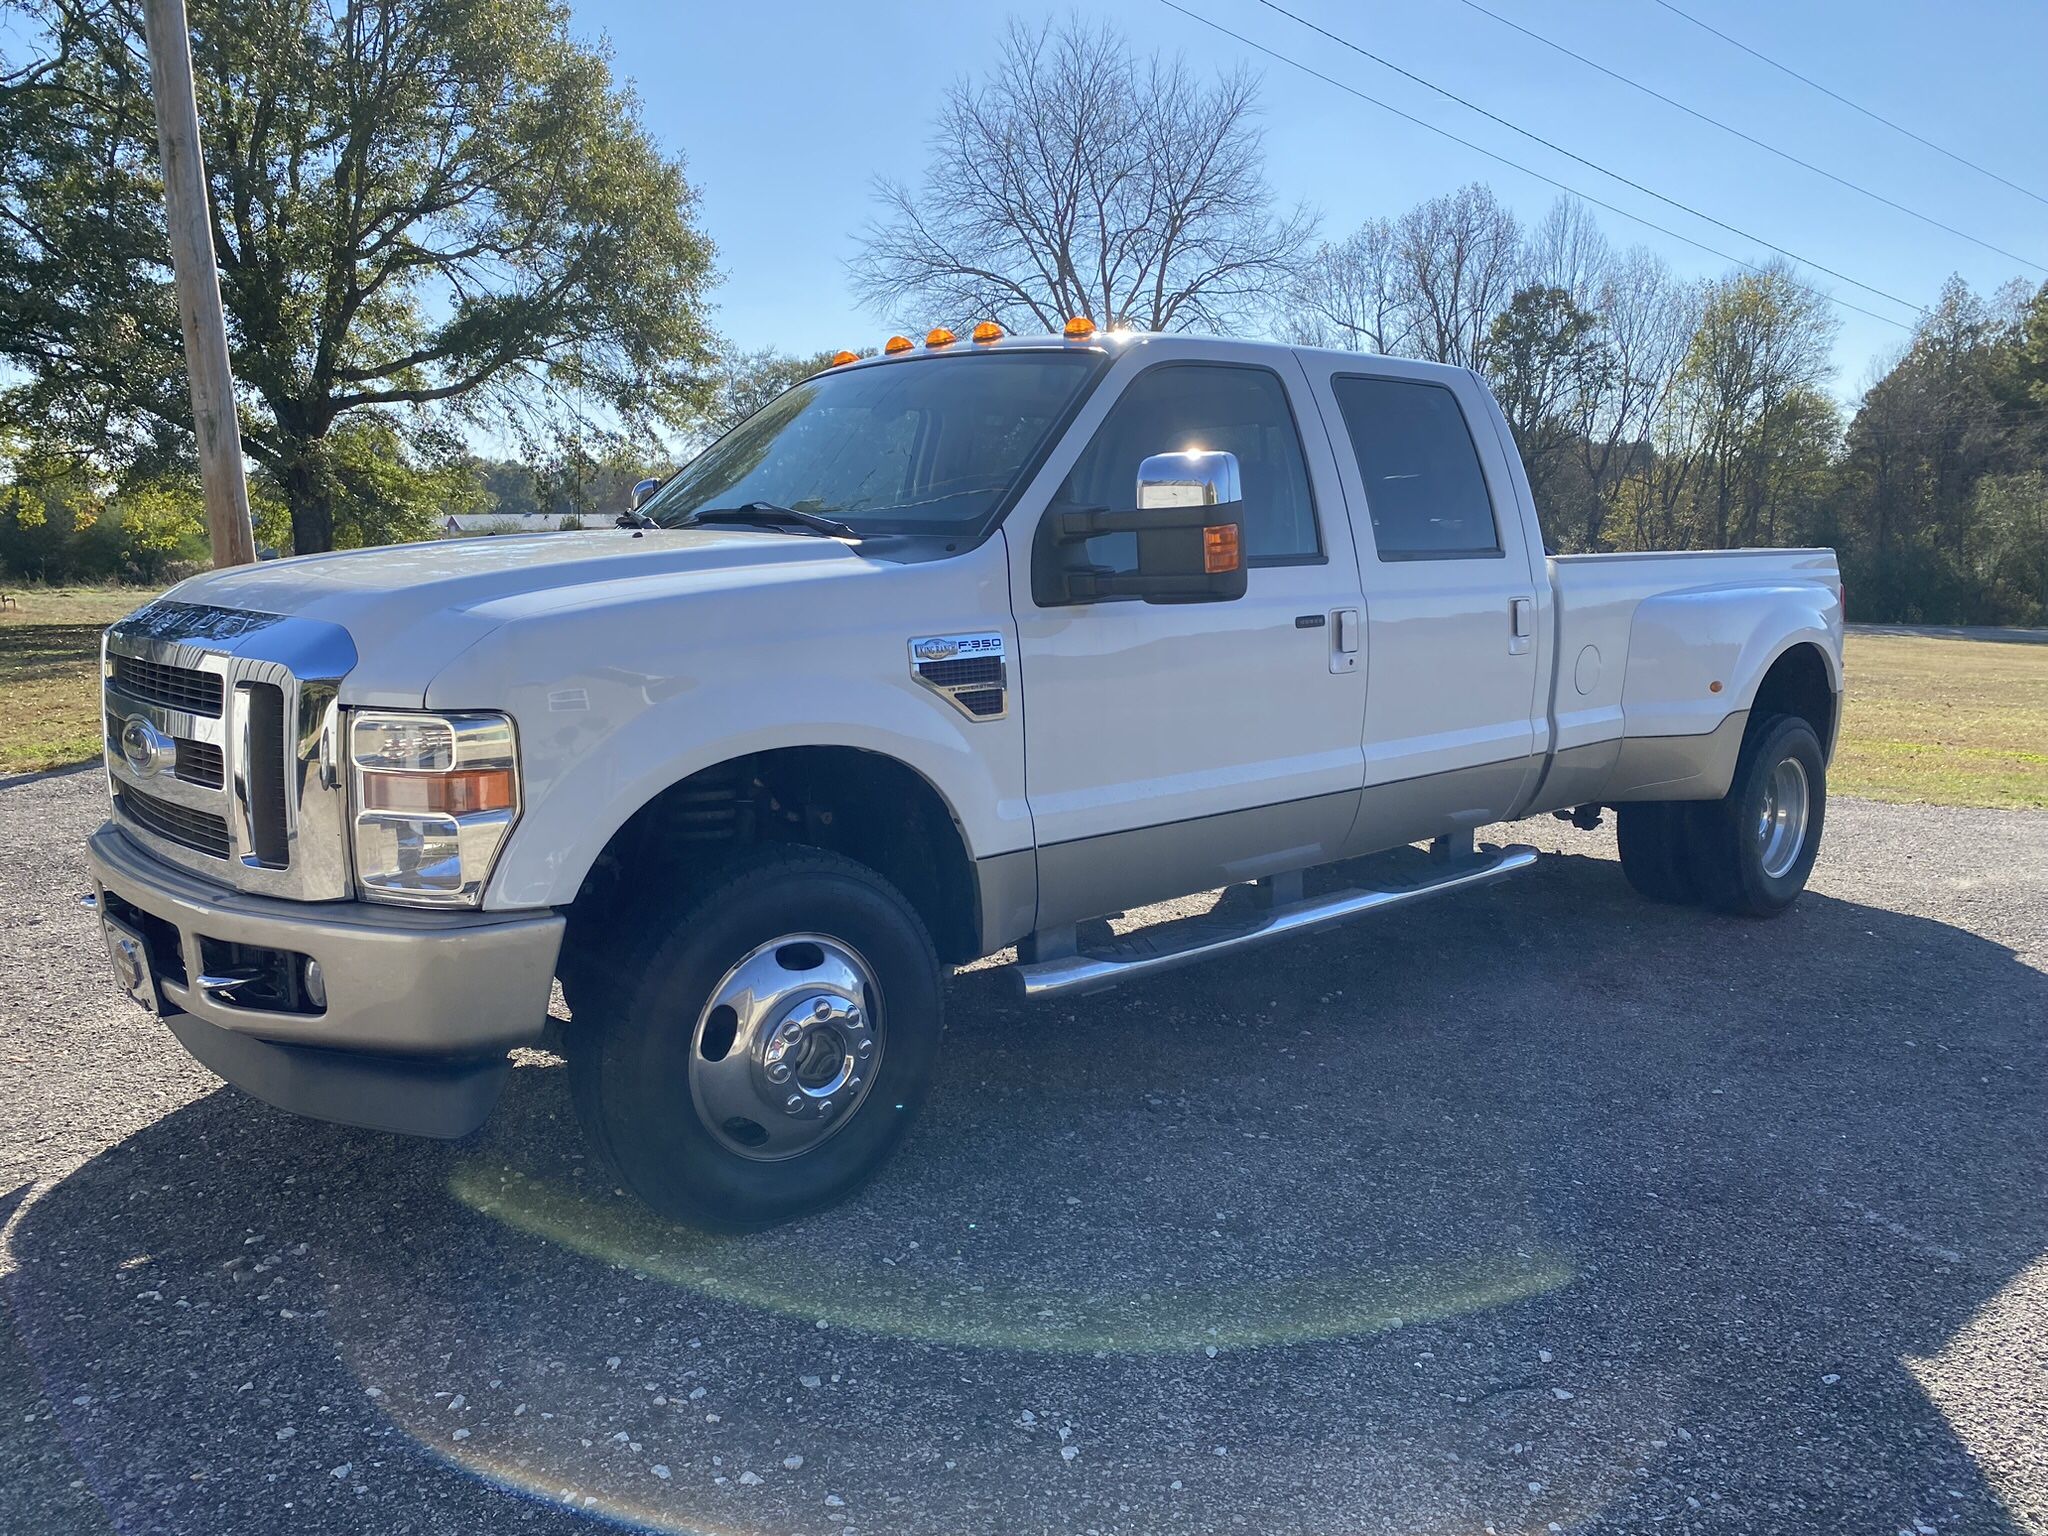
[141,0,256,565]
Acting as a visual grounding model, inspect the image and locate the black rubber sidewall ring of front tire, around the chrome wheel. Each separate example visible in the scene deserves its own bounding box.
[598,868,942,1229]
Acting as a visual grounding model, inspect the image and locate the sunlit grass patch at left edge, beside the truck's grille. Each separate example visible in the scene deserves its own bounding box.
[0,582,156,776]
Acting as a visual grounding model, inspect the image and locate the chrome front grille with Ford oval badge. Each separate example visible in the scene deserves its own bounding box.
[100,600,356,901]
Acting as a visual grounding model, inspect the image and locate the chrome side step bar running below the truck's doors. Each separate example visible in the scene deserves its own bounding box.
[1010,844,1536,997]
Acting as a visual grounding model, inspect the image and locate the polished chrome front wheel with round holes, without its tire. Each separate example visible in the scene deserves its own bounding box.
[690,934,883,1161]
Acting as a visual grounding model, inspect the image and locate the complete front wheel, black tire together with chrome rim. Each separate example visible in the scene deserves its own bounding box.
[569,848,942,1231]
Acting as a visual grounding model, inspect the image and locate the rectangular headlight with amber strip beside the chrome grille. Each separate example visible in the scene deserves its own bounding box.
[348,711,518,907]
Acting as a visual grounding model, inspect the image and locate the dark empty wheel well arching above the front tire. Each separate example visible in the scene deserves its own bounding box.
[565,748,981,965]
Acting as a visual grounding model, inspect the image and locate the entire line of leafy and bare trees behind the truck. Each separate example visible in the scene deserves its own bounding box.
[0,10,2048,623]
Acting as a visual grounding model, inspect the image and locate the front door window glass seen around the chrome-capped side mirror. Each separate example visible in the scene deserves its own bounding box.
[1057,362,1323,571]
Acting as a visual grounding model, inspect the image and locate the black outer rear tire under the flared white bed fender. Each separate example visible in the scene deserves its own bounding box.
[1690,715,1827,918]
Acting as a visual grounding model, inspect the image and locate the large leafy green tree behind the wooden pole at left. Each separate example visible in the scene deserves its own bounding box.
[0,0,713,551]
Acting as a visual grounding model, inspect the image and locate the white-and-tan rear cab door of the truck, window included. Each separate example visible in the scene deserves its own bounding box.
[1307,352,1542,823]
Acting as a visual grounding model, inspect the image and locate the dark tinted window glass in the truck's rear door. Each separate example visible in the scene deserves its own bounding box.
[1329,375,1501,559]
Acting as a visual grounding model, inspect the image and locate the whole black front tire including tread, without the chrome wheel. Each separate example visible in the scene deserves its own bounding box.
[569,846,944,1233]
